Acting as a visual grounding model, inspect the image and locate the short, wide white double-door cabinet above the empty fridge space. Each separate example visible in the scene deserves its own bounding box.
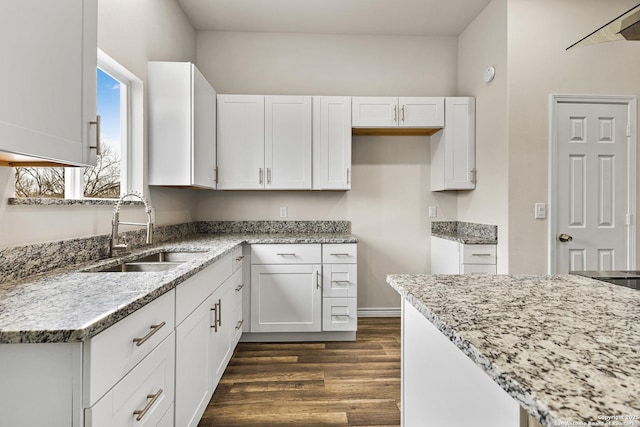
[352,96,444,128]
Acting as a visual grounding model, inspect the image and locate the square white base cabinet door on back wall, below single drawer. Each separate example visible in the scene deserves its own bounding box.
[251,264,322,332]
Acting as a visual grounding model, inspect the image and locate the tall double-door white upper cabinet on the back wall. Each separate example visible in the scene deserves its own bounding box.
[218,95,311,190]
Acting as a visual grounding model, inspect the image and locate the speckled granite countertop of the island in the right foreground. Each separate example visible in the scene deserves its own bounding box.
[387,275,640,426]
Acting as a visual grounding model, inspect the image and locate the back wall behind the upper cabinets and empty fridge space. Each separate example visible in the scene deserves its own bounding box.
[196,32,457,308]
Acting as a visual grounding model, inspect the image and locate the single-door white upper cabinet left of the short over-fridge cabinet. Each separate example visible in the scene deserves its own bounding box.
[313,96,351,190]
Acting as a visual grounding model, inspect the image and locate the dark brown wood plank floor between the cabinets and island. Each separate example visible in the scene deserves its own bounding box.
[198,318,400,427]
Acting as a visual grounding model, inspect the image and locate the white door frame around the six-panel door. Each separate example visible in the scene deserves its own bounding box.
[547,94,638,274]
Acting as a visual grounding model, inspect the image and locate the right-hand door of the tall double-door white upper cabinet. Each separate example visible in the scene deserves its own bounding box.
[264,96,311,190]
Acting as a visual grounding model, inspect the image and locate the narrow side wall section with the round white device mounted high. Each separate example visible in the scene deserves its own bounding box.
[458,0,509,273]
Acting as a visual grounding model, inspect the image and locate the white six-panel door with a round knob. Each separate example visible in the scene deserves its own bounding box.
[552,100,635,273]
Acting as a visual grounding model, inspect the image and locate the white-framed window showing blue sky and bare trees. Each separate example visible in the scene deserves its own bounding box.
[15,51,142,199]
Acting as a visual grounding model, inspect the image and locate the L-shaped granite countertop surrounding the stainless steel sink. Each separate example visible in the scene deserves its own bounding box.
[0,233,358,343]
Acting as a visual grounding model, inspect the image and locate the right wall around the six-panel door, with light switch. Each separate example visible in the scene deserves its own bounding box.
[508,0,640,273]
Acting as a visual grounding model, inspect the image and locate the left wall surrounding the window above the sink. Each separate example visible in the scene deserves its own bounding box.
[0,0,196,247]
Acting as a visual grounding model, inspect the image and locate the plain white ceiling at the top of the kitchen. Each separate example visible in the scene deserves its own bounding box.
[177,0,491,36]
